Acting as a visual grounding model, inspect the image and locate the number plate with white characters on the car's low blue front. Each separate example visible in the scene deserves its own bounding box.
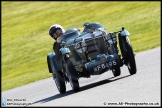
[93,60,117,72]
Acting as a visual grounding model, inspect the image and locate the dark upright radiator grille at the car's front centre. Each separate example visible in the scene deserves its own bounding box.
[86,37,107,59]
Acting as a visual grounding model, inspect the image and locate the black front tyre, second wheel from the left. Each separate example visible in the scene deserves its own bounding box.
[65,58,79,92]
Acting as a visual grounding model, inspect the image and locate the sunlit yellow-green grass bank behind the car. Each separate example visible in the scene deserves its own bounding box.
[1,1,161,91]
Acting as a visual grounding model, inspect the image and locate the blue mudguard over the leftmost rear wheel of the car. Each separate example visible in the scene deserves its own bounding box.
[47,52,61,73]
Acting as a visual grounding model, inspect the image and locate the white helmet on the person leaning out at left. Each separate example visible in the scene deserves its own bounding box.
[49,24,65,40]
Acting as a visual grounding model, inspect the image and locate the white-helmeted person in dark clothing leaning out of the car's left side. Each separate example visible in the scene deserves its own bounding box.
[49,24,65,52]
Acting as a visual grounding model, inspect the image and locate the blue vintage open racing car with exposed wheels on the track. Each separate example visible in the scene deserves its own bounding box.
[47,22,137,93]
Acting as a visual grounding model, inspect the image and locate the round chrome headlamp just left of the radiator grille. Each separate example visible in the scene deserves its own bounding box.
[75,41,87,53]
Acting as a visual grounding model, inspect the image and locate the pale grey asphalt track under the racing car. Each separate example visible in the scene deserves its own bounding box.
[1,47,161,107]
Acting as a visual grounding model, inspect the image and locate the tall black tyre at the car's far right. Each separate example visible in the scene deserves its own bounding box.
[119,36,137,75]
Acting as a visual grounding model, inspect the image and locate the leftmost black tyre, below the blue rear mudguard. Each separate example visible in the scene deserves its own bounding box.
[50,59,66,94]
